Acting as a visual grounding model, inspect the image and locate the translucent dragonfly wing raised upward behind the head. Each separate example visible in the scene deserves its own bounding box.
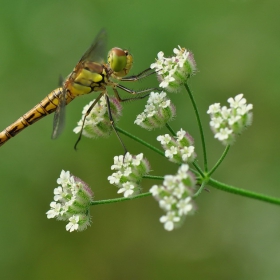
[79,29,107,63]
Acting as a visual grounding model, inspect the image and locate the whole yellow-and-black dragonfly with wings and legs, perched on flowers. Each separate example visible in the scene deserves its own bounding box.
[0,29,156,150]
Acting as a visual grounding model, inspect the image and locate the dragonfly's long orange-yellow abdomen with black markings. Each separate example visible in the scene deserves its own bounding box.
[0,88,74,146]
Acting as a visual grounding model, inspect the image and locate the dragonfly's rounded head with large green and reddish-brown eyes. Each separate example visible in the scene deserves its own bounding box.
[108,48,133,78]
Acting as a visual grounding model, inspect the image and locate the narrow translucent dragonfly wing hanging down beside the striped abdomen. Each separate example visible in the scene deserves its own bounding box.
[52,89,66,139]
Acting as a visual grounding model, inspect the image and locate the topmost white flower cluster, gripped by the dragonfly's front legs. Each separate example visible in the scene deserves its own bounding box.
[150,46,196,92]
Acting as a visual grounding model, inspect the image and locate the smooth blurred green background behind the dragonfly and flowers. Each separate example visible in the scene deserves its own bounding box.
[0,0,280,280]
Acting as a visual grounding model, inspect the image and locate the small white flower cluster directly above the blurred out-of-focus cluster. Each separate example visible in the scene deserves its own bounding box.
[157,128,196,163]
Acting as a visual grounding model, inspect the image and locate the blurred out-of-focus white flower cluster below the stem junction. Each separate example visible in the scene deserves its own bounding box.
[150,164,196,231]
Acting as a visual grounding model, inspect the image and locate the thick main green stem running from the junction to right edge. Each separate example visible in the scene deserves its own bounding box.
[207,178,280,205]
